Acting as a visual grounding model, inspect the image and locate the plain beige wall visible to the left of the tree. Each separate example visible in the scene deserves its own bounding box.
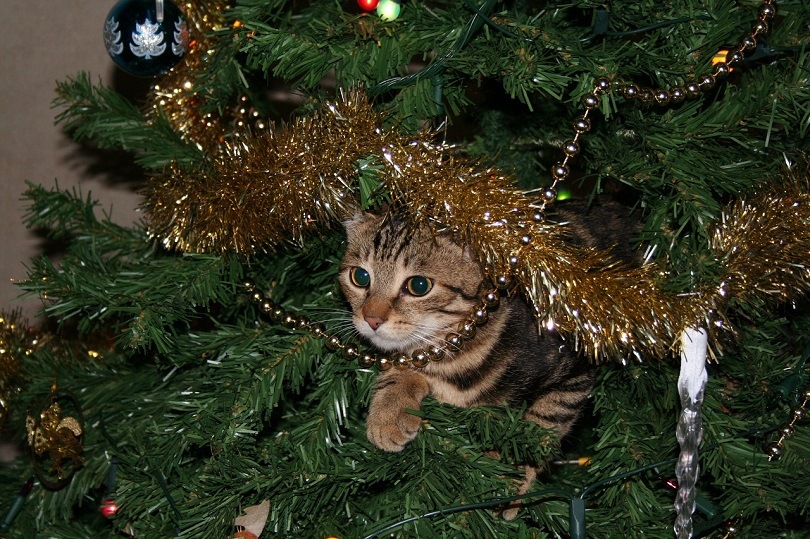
[0,0,141,322]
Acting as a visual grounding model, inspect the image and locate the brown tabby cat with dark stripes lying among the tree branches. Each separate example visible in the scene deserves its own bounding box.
[340,205,626,452]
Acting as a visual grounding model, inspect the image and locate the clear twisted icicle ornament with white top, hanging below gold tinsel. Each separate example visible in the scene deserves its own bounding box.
[675,328,708,539]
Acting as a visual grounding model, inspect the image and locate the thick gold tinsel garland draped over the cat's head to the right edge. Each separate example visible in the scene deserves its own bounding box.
[147,91,810,361]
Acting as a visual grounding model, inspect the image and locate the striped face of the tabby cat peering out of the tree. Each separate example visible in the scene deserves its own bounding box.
[340,214,482,352]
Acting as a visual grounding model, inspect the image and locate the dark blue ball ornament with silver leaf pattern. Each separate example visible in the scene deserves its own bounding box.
[104,0,188,77]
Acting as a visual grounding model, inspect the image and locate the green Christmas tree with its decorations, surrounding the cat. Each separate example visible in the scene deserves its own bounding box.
[0,0,810,538]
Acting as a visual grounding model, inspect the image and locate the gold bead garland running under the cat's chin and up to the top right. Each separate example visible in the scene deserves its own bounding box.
[243,0,772,372]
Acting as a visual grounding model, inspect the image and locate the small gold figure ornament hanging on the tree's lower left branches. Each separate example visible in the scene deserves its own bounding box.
[25,386,84,489]
